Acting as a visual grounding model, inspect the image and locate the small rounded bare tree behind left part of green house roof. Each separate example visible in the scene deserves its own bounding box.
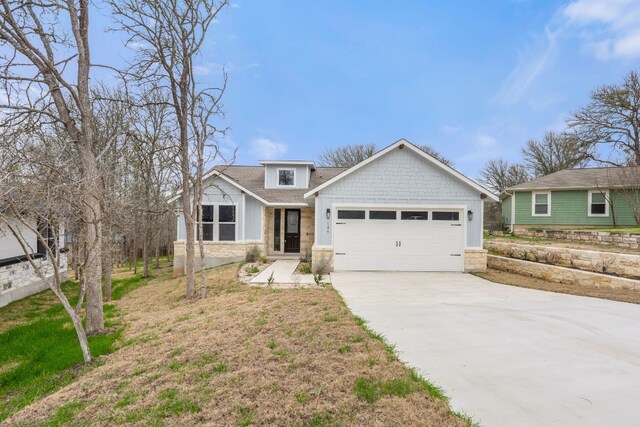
[522,132,593,177]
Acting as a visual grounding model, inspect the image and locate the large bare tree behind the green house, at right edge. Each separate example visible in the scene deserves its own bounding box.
[567,71,640,166]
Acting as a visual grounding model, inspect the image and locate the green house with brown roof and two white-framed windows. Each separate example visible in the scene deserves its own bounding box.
[500,167,640,232]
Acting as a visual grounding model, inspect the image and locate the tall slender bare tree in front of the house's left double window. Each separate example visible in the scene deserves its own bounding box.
[109,0,228,299]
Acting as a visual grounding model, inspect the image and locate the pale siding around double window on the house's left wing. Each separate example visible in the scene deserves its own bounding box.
[176,179,262,241]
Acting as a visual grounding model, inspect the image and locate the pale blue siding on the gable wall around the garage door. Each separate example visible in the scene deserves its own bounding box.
[315,149,483,247]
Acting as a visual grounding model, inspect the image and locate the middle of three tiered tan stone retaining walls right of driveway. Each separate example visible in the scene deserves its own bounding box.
[484,240,640,278]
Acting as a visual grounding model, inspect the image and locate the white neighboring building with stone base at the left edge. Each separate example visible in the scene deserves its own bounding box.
[0,220,67,307]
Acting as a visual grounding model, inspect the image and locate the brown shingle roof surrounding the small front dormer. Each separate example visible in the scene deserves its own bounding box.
[214,166,346,203]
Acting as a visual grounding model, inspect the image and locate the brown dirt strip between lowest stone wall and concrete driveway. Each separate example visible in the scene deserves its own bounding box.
[474,268,640,304]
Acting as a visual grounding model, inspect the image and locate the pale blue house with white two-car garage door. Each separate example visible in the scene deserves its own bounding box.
[173,139,498,275]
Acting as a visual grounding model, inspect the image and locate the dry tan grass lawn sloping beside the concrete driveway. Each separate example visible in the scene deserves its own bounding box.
[6,264,467,426]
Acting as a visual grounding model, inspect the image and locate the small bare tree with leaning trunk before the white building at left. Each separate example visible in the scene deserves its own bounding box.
[0,127,91,362]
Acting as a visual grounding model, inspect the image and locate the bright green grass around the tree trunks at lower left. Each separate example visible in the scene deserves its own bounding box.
[0,260,172,421]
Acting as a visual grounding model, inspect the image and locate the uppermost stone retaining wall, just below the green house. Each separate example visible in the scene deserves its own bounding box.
[514,225,640,249]
